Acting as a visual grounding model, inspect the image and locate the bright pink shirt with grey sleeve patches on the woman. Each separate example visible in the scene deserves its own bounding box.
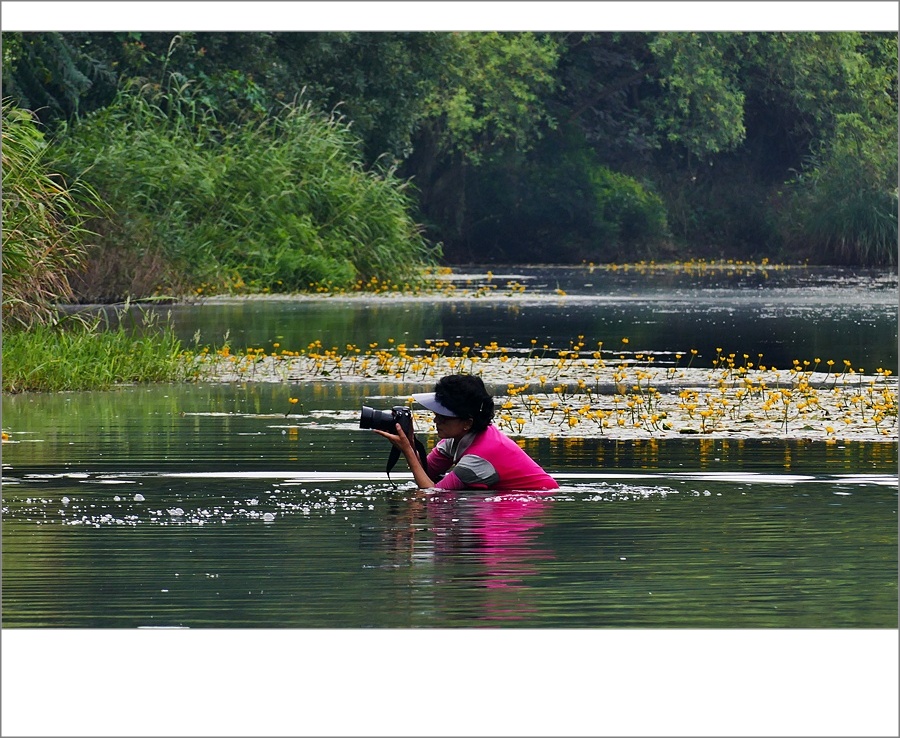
[428,425,559,490]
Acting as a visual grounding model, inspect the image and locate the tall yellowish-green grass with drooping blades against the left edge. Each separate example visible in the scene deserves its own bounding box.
[2,100,100,330]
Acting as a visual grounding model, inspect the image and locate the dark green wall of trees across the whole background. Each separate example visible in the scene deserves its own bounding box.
[3,32,897,276]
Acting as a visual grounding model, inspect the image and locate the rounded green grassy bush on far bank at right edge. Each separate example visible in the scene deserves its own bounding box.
[786,113,897,266]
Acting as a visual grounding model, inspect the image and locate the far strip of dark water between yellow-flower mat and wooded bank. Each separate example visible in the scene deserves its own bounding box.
[79,266,898,373]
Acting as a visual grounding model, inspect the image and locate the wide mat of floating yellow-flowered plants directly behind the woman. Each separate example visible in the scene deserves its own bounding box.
[195,335,897,442]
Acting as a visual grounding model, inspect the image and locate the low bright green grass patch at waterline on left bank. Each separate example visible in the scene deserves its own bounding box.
[3,311,190,393]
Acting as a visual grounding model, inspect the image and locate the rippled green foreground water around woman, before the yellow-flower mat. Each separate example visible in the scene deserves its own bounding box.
[3,384,897,628]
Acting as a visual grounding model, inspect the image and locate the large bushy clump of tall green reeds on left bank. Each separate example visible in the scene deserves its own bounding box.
[52,75,435,297]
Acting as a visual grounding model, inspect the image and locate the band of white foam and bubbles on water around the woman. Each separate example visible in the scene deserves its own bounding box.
[2,470,898,527]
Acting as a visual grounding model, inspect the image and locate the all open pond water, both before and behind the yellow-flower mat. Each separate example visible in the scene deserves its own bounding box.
[2,269,898,629]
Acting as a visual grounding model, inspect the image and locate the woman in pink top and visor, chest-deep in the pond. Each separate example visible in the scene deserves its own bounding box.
[375,374,559,490]
